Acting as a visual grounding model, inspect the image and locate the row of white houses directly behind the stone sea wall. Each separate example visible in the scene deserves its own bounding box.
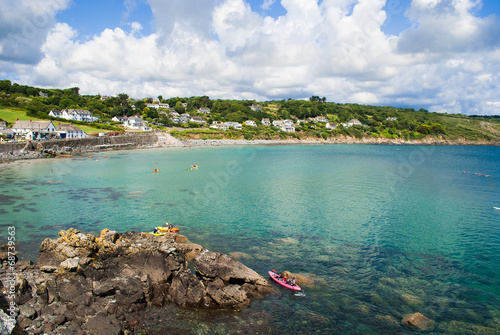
[0,120,88,140]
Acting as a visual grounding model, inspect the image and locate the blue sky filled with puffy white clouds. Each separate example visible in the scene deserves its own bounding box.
[0,0,500,114]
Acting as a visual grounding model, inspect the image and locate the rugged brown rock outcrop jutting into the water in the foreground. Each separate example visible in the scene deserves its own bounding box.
[0,228,272,334]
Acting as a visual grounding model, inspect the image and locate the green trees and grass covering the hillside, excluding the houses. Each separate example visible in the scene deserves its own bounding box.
[0,80,500,142]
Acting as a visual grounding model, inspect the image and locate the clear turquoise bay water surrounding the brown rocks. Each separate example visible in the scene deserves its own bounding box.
[0,145,500,334]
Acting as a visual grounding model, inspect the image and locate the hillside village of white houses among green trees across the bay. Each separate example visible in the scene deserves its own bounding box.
[0,80,500,142]
